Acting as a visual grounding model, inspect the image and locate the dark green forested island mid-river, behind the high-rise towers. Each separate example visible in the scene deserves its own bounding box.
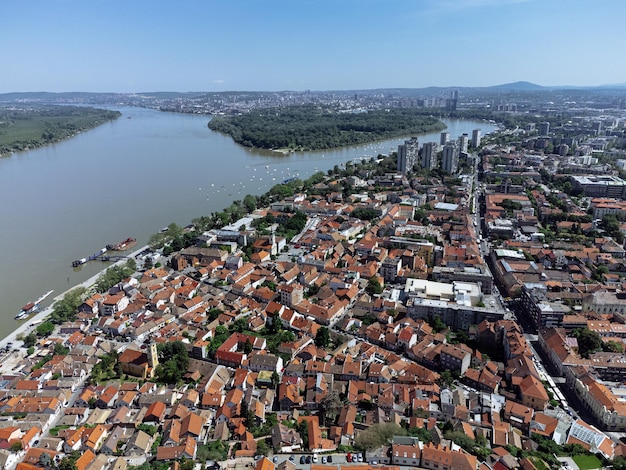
[209,105,446,151]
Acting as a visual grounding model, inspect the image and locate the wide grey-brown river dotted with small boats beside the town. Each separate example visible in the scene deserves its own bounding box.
[0,108,495,338]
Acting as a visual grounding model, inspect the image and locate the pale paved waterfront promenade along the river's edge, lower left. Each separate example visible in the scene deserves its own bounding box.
[0,245,149,373]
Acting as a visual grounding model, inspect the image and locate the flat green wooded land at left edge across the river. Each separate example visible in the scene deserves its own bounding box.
[0,104,122,156]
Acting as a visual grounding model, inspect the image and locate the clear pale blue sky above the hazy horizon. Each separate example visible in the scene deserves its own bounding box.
[0,0,626,93]
